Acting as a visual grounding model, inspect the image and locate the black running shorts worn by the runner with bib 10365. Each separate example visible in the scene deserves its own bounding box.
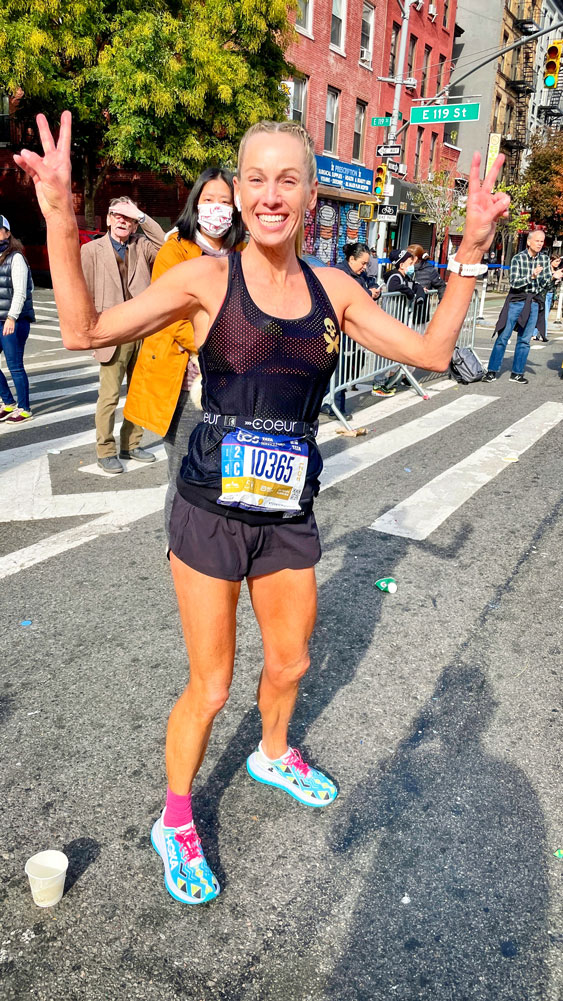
[170,493,321,581]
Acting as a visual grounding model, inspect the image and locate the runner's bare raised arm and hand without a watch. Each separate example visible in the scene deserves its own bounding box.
[14,111,219,350]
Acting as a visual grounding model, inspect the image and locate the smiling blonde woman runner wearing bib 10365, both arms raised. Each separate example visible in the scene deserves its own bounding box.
[15,112,510,904]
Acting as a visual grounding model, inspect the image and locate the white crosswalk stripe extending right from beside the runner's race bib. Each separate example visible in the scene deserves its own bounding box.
[321,394,498,490]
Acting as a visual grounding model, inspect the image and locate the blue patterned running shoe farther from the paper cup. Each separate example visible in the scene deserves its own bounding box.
[246,744,332,807]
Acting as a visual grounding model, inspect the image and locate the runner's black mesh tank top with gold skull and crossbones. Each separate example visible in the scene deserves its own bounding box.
[177,252,340,525]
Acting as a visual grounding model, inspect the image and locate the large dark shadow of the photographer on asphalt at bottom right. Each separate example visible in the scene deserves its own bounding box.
[325,663,549,1001]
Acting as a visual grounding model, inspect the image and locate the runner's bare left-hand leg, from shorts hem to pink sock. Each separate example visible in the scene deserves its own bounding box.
[166,553,240,796]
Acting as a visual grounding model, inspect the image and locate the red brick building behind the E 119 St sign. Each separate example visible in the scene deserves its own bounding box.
[288,0,459,263]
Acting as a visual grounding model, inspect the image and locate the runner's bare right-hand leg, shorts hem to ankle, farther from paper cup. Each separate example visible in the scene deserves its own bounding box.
[248,568,317,759]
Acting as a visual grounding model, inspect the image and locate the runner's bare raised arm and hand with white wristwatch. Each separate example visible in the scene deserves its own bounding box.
[316,153,510,371]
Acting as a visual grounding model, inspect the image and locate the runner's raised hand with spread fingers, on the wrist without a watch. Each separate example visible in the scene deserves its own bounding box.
[14,111,74,219]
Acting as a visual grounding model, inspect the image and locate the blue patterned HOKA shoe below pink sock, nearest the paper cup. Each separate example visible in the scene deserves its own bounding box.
[150,816,220,904]
